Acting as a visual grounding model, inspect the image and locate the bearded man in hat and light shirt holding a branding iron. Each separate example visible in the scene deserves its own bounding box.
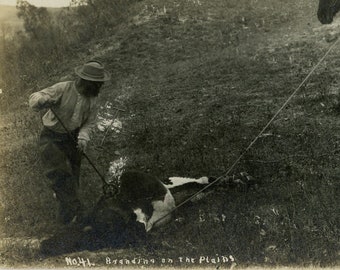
[29,61,110,224]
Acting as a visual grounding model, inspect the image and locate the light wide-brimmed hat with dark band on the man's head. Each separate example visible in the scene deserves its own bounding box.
[74,61,111,82]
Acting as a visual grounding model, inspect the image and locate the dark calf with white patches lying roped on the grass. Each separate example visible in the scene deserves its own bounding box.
[40,171,255,255]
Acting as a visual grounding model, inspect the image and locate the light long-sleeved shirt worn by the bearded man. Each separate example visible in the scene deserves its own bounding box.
[29,81,98,141]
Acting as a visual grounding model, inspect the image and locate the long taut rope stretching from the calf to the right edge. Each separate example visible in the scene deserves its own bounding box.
[154,35,340,224]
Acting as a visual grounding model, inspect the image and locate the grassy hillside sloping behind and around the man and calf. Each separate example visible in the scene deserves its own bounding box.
[0,0,340,268]
